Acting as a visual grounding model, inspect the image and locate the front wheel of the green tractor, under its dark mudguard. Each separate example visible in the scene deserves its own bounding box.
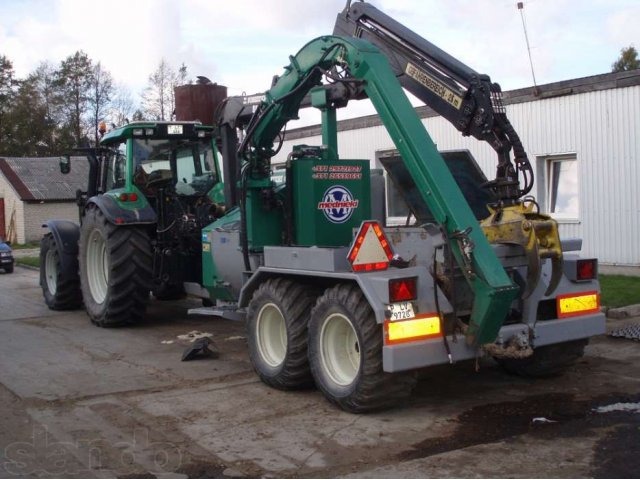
[40,233,82,310]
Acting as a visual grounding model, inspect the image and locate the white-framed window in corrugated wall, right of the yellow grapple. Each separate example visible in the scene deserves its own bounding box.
[545,156,580,219]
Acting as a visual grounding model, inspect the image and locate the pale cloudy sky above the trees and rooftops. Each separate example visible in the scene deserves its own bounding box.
[0,0,640,124]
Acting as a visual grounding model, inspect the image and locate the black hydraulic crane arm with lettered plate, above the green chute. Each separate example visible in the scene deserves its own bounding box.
[334,0,533,204]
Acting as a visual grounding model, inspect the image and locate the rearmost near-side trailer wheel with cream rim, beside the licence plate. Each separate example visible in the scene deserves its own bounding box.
[309,284,416,413]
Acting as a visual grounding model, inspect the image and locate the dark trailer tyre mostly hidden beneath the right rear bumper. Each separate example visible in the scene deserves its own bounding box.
[496,339,589,377]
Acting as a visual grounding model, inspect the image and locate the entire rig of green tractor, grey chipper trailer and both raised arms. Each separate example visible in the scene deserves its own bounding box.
[42,3,604,412]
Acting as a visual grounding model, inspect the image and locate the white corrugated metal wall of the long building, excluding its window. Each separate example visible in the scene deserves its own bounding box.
[275,86,640,266]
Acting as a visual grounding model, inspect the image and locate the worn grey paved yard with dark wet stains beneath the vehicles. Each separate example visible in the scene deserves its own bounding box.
[0,267,640,478]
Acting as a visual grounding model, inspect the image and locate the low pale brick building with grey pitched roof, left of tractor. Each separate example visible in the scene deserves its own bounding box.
[0,157,89,243]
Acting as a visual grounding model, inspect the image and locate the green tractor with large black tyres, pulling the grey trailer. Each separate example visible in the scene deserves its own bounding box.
[40,122,224,327]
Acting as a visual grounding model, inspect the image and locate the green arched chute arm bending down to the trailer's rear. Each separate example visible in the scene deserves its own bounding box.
[239,36,518,343]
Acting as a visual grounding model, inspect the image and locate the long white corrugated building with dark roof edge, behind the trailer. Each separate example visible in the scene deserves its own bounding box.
[275,70,640,270]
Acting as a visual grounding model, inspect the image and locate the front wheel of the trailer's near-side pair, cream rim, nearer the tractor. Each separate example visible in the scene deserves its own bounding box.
[247,278,316,390]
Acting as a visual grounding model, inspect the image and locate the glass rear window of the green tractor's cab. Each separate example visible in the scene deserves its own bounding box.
[133,139,218,195]
